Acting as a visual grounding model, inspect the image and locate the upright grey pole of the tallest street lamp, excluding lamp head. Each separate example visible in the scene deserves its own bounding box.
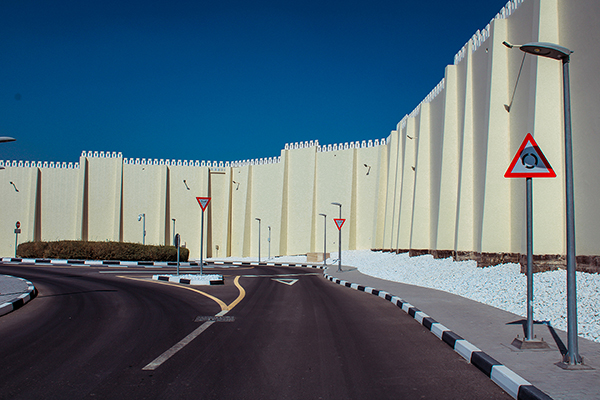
[562,57,582,364]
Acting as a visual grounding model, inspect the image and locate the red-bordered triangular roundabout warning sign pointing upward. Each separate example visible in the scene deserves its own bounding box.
[504,133,556,178]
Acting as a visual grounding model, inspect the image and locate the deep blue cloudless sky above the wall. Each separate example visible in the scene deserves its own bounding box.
[0,0,506,162]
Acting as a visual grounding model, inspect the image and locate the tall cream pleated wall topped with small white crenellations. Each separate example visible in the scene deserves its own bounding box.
[0,0,600,266]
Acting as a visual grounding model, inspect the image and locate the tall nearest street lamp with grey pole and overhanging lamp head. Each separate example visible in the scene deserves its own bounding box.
[503,42,583,365]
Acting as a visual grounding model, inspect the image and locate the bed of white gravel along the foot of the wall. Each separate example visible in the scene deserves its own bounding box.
[211,250,600,343]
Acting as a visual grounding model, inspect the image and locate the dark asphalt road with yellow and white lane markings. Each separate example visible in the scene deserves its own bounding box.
[0,266,510,399]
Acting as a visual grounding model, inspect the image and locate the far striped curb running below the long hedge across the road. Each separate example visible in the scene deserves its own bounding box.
[0,257,324,269]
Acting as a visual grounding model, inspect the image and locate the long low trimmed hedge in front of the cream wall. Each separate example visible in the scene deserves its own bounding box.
[17,240,190,261]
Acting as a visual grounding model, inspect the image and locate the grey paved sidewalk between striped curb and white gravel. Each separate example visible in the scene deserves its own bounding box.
[326,266,600,400]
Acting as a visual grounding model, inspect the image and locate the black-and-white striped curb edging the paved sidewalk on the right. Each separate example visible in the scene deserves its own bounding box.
[324,274,551,400]
